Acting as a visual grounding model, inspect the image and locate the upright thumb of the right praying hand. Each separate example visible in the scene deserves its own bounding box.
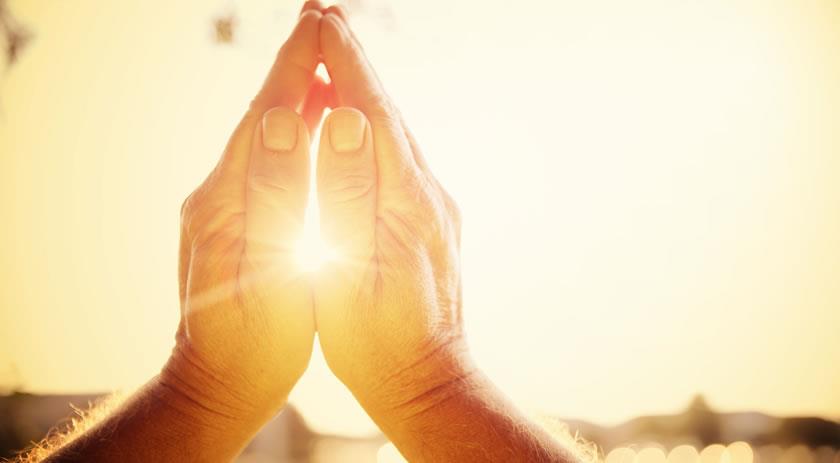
[317,108,377,266]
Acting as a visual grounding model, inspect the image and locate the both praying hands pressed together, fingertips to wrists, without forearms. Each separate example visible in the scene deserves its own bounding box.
[163,0,469,432]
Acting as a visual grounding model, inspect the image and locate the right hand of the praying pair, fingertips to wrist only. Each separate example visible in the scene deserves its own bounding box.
[315,8,473,420]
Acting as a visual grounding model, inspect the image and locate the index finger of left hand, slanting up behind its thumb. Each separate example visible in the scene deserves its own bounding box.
[219,10,321,183]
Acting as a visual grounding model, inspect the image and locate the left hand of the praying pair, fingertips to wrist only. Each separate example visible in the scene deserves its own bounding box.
[161,4,324,430]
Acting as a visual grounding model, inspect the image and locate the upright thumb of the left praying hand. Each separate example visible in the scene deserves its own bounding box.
[245,107,309,263]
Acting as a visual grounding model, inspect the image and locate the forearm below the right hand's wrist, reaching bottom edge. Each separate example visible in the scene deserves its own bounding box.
[362,352,581,462]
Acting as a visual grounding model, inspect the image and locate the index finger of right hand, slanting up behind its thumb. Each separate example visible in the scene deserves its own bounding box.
[320,14,417,194]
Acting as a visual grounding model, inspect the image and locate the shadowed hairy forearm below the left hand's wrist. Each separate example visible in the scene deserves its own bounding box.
[43,377,264,462]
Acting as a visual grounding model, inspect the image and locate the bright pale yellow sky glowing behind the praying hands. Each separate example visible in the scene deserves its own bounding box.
[0,0,840,432]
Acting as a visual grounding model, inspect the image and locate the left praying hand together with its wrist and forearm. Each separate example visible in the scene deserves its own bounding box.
[41,8,332,461]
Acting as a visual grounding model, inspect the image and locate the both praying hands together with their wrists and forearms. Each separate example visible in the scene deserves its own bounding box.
[24,2,575,461]
